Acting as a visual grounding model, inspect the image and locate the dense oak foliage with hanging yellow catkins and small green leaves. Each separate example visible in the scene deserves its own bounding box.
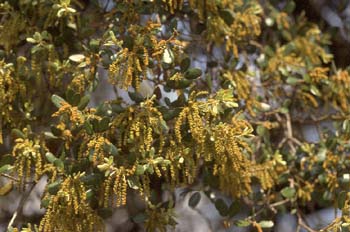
[0,0,350,231]
